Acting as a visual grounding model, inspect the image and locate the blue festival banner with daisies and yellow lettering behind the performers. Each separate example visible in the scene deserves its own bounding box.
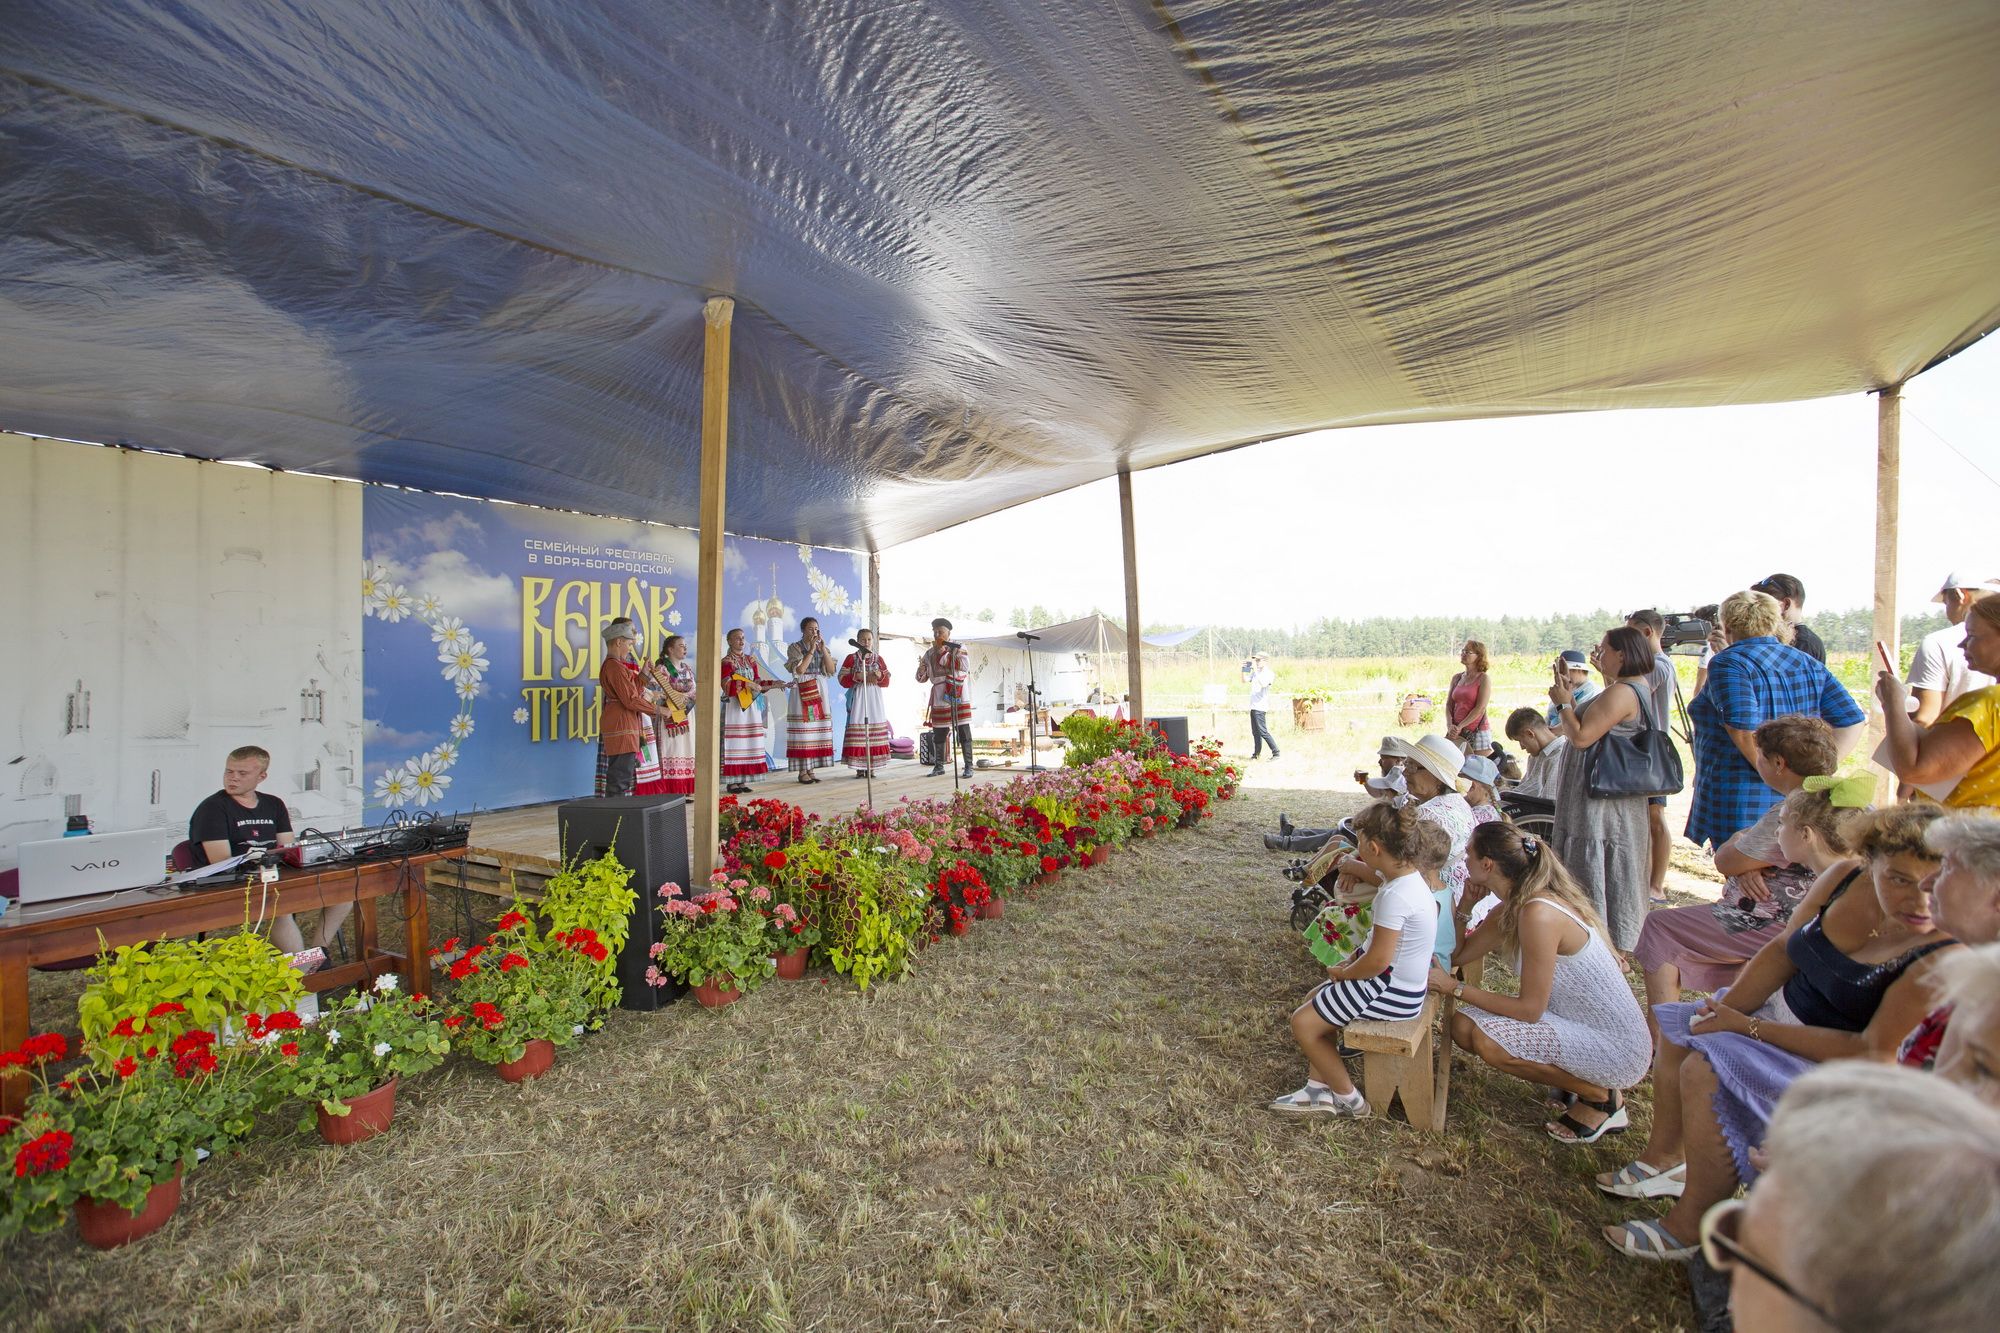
[362,486,868,819]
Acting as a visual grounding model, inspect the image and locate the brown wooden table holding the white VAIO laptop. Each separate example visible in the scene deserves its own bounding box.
[0,849,464,1115]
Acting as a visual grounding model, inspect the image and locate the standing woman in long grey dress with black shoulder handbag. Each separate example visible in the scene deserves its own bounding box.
[1548,624,1680,955]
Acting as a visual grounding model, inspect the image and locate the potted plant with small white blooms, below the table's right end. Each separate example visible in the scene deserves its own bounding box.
[280,973,452,1143]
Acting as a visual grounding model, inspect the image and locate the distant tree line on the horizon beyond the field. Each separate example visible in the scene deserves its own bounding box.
[882,602,1944,656]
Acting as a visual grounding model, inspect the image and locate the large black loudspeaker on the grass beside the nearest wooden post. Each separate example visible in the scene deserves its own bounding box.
[556,797,692,1011]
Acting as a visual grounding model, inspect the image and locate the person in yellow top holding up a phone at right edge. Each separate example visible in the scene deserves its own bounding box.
[1876,596,2000,809]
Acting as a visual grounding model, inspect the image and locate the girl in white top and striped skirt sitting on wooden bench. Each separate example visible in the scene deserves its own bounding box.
[1270,801,1438,1115]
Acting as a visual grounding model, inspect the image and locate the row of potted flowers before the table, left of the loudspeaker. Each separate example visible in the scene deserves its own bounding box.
[0,880,634,1249]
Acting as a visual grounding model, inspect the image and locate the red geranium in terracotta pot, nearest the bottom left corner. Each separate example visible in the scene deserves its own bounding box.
[0,1001,284,1249]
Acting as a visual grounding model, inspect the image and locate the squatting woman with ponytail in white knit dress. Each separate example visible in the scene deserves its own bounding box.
[1430,825,1652,1143]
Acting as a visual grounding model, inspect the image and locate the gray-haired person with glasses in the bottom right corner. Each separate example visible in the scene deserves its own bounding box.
[1700,1061,2000,1333]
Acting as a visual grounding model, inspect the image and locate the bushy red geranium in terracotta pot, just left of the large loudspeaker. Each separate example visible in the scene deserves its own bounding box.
[444,903,592,1083]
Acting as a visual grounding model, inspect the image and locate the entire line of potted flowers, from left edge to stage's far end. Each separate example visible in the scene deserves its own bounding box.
[0,727,1236,1247]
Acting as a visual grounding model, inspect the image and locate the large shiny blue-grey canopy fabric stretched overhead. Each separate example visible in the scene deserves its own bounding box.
[0,0,2000,548]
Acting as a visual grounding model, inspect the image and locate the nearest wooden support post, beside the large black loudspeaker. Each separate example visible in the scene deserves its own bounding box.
[688,296,736,893]
